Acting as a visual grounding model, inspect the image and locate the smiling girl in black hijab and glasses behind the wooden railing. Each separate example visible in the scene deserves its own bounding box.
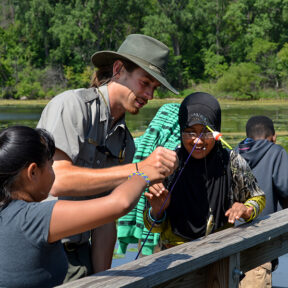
[144,92,265,248]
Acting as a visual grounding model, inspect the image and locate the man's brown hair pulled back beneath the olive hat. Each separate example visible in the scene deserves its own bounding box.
[90,59,139,87]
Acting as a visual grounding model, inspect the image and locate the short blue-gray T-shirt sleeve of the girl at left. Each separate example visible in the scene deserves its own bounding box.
[21,200,57,247]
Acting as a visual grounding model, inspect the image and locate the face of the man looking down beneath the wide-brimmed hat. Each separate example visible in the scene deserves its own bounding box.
[117,67,160,114]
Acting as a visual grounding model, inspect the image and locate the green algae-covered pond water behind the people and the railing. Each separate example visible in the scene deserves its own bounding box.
[0,102,288,288]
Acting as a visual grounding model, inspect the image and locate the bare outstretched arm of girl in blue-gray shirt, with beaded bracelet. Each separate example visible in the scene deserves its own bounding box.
[48,166,172,243]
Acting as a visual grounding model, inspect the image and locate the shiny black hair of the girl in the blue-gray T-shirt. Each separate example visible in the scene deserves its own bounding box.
[0,126,55,209]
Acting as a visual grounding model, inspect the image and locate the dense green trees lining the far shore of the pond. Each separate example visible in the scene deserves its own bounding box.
[0,0,288,98]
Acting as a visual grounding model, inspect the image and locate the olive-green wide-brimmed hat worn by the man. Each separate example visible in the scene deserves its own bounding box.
[91,34,179,94]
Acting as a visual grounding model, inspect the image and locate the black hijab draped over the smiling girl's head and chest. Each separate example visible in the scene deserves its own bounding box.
[167,92,230,240]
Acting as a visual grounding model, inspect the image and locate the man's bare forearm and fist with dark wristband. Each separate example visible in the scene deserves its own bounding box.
[50,147,178,197]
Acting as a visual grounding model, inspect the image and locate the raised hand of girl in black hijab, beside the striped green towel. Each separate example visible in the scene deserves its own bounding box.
[144,183,170,219]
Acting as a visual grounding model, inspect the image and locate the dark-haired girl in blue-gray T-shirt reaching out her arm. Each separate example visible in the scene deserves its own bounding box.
[0,126,174,288]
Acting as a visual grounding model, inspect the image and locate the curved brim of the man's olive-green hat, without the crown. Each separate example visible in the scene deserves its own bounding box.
[91,51,179,95]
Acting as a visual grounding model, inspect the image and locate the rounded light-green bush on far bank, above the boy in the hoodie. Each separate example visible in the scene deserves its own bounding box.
[217,63,262,99]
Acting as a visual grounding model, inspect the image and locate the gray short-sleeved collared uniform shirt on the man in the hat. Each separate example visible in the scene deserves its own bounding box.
[37,86,135,243]
